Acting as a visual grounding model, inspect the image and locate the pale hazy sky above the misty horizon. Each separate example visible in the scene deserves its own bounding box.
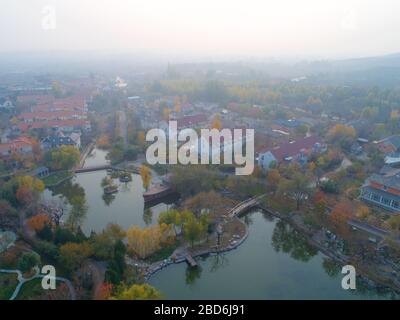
[0,0,400,58]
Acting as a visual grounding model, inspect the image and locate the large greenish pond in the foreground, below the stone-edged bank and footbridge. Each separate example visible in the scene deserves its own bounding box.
[149,211,391,299]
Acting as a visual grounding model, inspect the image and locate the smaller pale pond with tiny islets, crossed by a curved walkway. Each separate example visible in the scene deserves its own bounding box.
[44,149,172,235]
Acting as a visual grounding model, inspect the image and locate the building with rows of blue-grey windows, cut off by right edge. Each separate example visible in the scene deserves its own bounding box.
[360,169,400,213]
